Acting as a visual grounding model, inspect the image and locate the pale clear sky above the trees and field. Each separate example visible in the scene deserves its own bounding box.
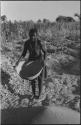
[1,1,80,21]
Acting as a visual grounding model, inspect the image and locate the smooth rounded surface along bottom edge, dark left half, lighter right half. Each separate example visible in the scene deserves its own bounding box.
[1,106,80,125]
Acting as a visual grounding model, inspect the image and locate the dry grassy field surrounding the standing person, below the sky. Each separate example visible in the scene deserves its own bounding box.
[0,15,80,112]
